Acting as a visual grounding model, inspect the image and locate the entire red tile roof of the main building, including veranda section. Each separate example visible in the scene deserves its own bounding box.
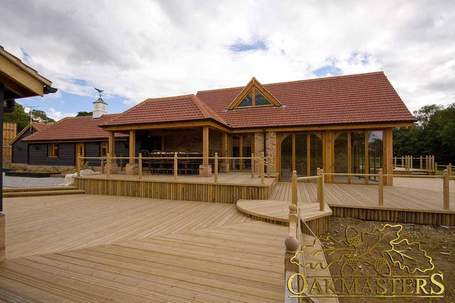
[103,72,415,128]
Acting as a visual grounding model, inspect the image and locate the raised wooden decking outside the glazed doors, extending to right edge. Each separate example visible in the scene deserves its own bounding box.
[271,178,455,225]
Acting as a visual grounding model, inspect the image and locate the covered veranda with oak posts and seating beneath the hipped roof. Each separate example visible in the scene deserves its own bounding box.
[100,121,269,177]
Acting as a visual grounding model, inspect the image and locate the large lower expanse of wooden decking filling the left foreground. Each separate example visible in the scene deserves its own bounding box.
[0,195,287,303]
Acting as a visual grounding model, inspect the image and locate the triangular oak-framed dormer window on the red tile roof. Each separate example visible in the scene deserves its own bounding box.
[228,78,281,109]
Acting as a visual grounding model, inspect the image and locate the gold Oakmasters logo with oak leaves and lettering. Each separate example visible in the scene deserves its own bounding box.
[287,224,445,298]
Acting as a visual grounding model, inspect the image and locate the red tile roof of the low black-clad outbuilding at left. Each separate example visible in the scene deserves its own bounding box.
[24,114,122,141]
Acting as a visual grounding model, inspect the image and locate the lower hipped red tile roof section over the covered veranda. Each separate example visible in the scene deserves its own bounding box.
[105,95,225,125]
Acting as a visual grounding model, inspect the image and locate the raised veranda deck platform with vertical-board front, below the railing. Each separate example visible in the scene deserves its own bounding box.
[75,173,275,203]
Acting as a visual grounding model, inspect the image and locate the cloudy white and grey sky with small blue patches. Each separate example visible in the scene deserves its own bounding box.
[0,0,455,120]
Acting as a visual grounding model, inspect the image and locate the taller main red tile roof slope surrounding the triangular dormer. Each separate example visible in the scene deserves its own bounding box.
[197,72,414,128]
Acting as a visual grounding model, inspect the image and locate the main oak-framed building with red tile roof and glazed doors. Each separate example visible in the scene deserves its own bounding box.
[100,72,415,183]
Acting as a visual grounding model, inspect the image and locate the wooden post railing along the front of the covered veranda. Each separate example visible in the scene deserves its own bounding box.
[76,153,266,184]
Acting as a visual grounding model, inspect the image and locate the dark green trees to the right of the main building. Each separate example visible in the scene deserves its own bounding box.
[393,103,455,164]
